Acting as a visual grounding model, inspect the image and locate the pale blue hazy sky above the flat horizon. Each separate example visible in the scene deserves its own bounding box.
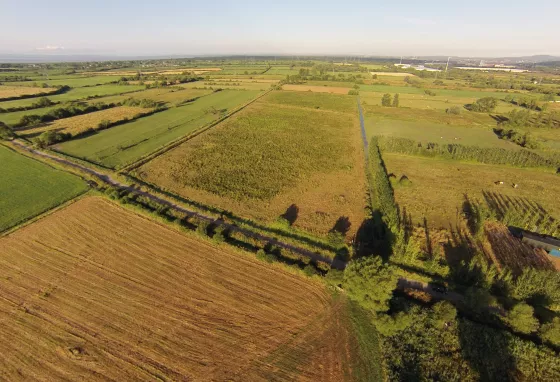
[0,0,560,57]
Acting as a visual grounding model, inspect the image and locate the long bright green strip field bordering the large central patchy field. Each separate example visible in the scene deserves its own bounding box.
[57,90,259,167]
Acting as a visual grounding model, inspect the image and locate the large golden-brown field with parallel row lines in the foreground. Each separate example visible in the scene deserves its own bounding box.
[0,197,356,381]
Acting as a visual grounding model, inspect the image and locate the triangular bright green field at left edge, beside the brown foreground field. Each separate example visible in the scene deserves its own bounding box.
[0,145,88,232]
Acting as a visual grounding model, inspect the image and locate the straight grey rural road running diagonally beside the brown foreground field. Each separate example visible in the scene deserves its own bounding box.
[12,140,346,270]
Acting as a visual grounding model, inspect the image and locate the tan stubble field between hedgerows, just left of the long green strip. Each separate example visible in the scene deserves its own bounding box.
[21,106,150,136]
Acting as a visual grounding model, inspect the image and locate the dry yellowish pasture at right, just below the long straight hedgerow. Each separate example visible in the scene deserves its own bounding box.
[383,153,560,228]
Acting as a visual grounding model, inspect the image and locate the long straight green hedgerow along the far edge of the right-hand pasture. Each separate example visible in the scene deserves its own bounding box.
[377,136,560,168]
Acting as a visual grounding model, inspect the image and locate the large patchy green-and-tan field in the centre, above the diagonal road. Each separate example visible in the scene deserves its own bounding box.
[135,91,365,237]
